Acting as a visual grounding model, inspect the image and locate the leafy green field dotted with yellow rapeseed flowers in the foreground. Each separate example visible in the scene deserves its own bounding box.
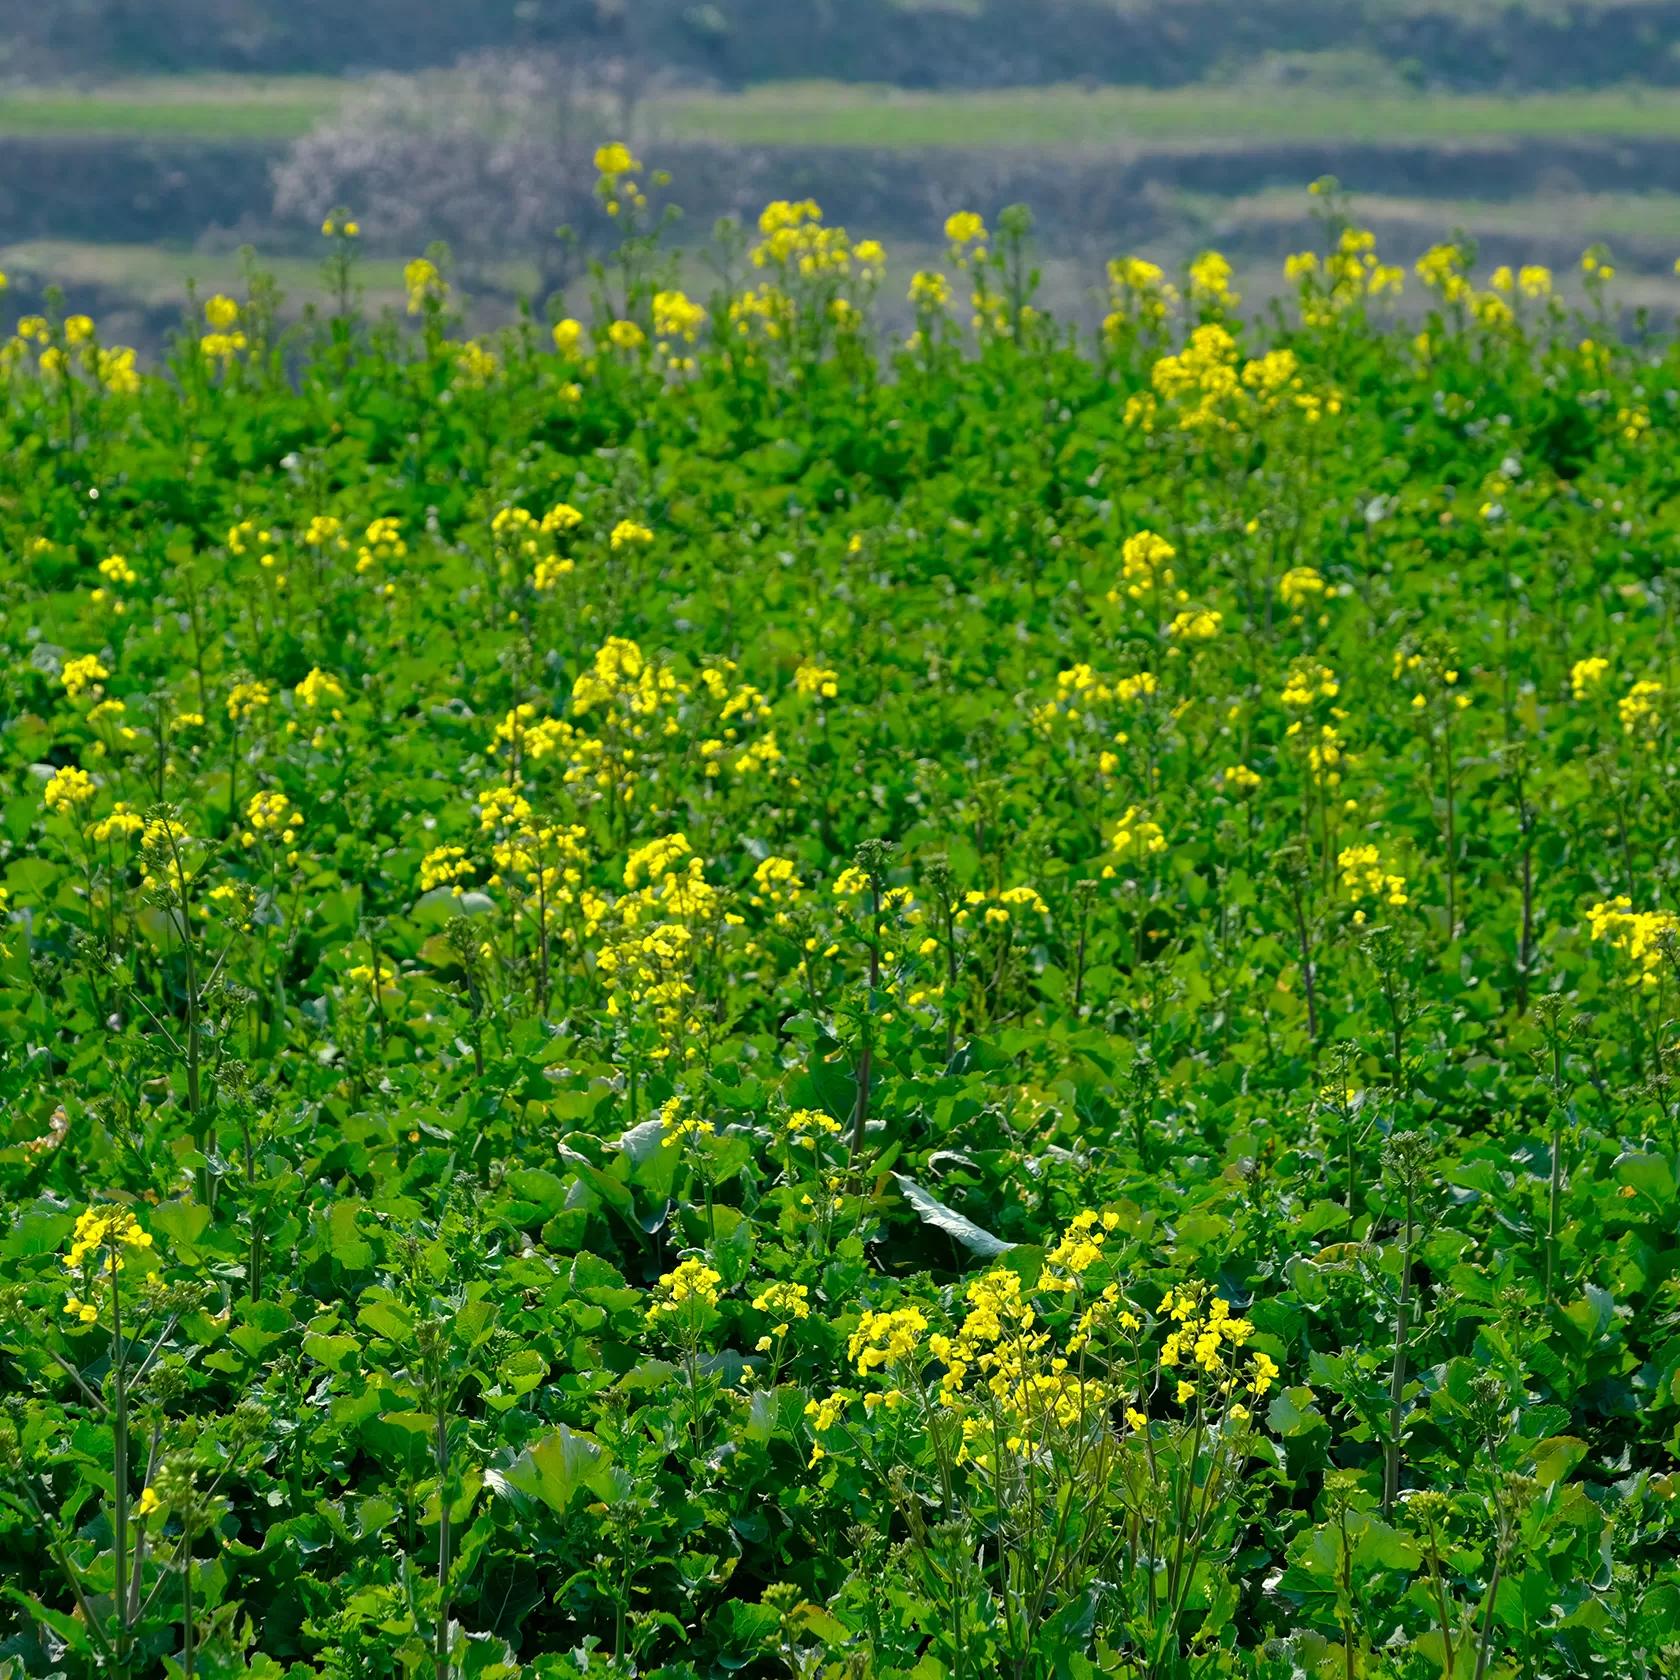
[0,163,1680,1680]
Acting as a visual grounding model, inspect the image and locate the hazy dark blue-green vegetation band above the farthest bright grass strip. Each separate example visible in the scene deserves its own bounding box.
[0,0,1680,89]
